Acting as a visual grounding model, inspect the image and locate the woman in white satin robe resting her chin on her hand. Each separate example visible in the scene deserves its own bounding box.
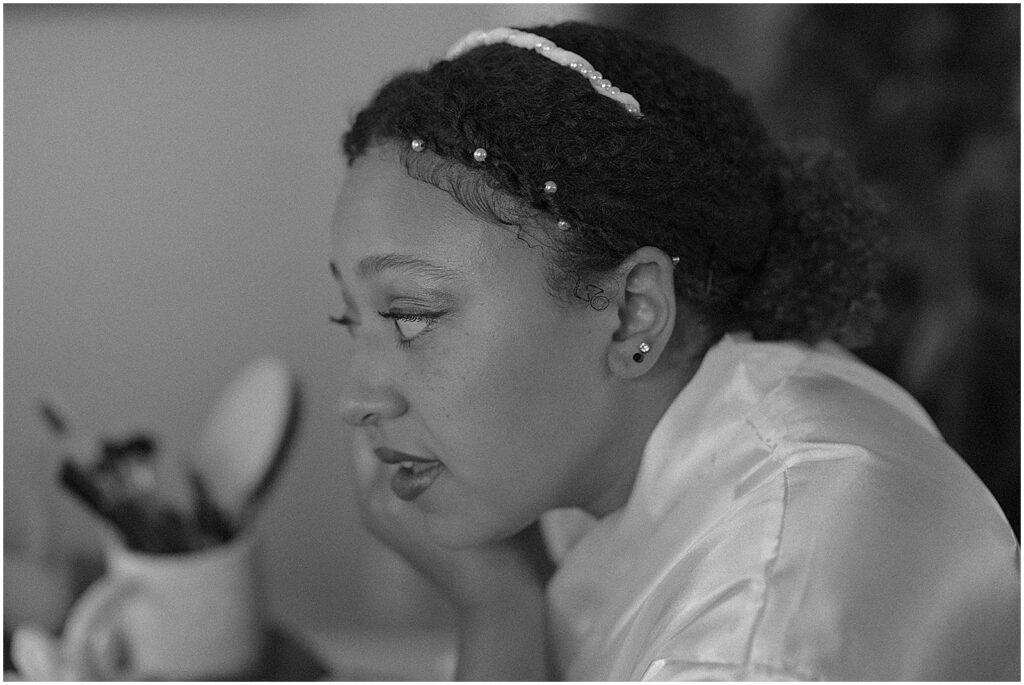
[332,24,1019,680]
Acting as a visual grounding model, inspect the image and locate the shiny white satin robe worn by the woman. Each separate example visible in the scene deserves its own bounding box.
[542,336,1021,681]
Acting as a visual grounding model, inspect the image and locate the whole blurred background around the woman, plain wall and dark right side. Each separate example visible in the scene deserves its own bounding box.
[3,4,1020,643]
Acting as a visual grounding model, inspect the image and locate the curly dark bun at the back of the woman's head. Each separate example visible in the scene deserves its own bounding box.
[740,141,887,347]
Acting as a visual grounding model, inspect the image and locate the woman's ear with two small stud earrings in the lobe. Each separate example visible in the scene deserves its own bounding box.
[608,247,676,379]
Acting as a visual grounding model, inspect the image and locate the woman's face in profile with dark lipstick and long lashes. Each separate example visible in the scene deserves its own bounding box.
[332,149,622,547]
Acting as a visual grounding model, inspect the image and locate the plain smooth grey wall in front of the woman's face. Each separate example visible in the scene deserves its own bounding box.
[3,5,588,628]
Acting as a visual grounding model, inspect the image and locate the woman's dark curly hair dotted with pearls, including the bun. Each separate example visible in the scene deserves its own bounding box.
[342,23,883,347]
